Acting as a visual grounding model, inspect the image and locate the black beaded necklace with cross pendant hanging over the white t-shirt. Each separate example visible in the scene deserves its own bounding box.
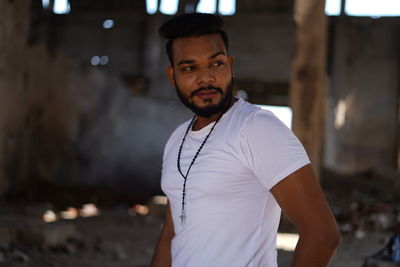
[177,112,224,224]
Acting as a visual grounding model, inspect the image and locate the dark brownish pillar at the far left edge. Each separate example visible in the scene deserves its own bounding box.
[0,1,30,195]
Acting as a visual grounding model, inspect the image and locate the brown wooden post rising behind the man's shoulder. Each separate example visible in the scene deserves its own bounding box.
[289,0,327,176]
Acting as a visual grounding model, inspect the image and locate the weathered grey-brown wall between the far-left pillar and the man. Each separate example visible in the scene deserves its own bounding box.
[21,46,191,194]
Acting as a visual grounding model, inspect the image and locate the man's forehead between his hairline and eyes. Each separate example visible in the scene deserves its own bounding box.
[172,33,226,59]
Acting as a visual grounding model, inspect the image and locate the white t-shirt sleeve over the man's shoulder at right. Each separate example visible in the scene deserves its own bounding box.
[242,110,310,190]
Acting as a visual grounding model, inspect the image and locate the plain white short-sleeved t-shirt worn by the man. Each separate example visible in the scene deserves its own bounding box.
[161,99,310,267]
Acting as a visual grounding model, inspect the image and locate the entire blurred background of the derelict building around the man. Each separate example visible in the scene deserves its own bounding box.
[0,0,400,267]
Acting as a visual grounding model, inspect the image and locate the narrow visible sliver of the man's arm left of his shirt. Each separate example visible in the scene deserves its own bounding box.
[151,202,175,267]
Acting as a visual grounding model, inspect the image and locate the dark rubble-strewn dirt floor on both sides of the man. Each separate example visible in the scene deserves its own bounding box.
[0,169,400,267]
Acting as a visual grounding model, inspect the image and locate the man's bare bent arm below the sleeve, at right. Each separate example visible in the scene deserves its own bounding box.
[271,165,340,267]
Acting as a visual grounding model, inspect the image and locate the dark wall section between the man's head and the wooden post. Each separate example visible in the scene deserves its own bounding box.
[225,14,294,83]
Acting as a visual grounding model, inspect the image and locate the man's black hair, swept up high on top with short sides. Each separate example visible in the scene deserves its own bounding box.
[158,13,229,66]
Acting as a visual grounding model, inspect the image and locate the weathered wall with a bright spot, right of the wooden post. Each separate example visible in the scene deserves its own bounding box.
[325,17,400,173]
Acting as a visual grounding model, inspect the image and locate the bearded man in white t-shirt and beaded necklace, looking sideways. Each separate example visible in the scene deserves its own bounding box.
[152,13,339,267]
